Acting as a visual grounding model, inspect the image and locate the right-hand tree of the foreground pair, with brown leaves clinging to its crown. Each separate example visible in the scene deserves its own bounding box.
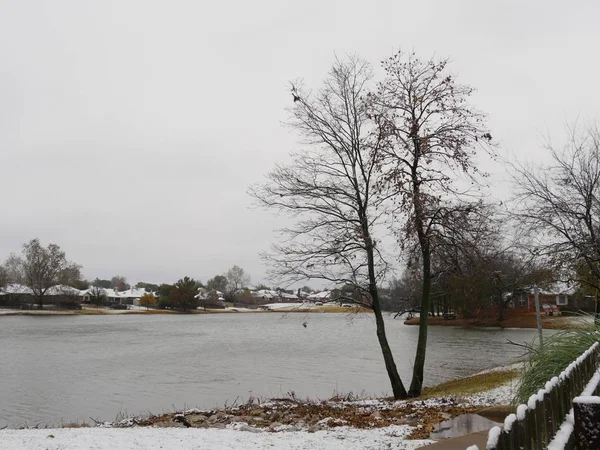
[371,52,491,396]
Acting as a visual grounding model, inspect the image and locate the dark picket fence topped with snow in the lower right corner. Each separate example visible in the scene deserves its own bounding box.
[469,342,600,450]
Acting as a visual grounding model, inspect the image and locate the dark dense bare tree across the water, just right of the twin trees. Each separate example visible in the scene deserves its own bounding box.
[432,202,548,321]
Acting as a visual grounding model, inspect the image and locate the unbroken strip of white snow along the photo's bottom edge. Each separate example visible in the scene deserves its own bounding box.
[0,425,433,450]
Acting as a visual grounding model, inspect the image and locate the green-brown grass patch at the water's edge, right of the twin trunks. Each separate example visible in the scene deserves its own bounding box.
[420,370,521,399]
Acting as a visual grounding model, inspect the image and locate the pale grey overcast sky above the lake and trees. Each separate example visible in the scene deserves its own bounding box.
[0,0,600,282]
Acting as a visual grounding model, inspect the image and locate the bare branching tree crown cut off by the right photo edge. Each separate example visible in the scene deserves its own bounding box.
[513,126,600,289]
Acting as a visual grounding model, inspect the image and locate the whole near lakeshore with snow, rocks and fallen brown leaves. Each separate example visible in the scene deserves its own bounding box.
[0,366,517,450]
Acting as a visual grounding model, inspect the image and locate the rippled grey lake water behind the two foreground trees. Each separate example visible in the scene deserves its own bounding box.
[0,313,536,427]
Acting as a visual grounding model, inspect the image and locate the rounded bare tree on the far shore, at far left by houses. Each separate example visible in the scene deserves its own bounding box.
[9,239,80,309]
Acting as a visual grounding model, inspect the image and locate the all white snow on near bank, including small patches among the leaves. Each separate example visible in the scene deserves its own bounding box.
[0,381,516,450]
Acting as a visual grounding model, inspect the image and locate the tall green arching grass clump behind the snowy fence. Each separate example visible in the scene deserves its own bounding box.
[515,314,600,404]
